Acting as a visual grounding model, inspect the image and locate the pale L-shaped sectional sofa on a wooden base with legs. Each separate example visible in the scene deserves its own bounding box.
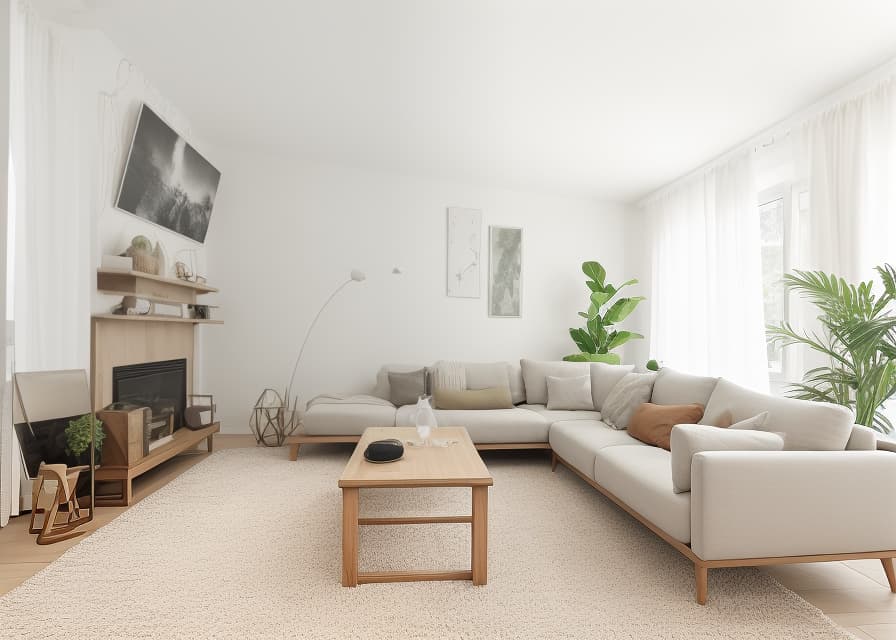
[291,360,896,604]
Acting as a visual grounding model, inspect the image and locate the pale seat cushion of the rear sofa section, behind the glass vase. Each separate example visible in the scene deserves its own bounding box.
[395,407,549,444]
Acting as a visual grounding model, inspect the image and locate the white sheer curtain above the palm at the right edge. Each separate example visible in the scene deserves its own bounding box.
[796,78,896,282]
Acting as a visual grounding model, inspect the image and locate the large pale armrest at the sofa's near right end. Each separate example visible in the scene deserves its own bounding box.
[691,451,896,560]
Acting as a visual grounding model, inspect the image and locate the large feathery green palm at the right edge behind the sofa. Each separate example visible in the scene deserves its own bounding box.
[768,264,896,433]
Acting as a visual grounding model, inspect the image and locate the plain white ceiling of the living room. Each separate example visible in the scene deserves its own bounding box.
[75,0,896,202]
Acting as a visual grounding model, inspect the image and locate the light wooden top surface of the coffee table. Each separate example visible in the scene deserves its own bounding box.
[339,427,494,488]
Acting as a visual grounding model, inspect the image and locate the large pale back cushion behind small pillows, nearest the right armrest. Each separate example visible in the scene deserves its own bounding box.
[700,378,853,451]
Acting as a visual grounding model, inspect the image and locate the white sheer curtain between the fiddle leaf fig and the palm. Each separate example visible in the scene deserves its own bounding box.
[645,152,768,391]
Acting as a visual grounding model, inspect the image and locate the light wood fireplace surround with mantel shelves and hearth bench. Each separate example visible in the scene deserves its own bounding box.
[90,268,223,505]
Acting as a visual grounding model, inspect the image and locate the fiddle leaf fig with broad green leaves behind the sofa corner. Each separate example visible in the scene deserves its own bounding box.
[563,261,644,364]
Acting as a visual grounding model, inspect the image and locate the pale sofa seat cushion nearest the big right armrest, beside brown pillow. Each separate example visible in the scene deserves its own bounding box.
[594,446,691,543]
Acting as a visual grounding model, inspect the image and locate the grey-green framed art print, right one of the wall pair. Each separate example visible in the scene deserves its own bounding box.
[488,227,523,318]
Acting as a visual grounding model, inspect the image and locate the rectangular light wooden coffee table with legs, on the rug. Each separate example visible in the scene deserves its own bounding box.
[339,427,494,587]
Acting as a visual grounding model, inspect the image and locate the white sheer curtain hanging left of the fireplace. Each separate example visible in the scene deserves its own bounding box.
[0,3,96,521]
